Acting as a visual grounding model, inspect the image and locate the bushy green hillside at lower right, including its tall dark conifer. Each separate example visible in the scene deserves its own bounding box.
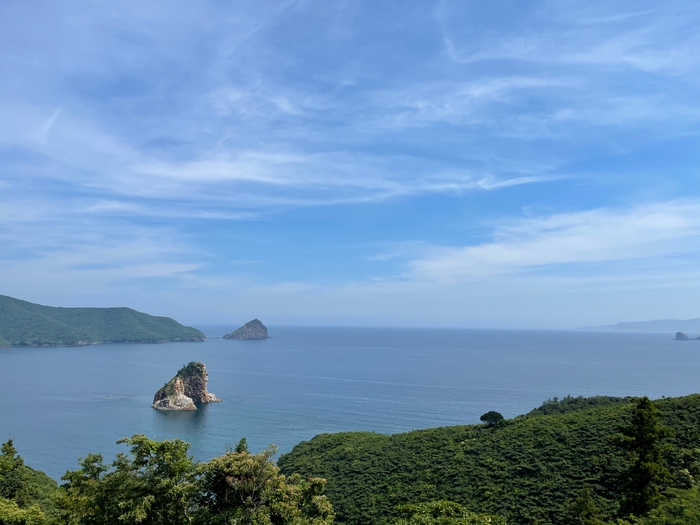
[279,395,700,525]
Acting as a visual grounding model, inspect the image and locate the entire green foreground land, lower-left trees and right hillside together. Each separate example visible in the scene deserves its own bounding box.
[0,395,700,525]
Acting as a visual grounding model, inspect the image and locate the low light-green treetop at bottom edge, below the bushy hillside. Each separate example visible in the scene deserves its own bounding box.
[392,500,506,525]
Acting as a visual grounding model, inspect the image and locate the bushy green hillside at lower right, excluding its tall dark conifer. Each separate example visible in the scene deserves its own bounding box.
[279,395,700,525]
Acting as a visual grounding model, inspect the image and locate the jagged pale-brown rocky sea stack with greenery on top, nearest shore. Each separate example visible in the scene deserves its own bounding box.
[152,361,222,410]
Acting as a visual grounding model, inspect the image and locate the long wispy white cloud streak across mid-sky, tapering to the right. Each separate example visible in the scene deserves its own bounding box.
[0,100,556,211]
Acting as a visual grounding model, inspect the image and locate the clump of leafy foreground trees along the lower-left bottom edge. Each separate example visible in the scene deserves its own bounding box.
[0,435,333,525]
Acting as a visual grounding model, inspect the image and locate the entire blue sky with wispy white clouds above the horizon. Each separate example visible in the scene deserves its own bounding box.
[0,0,700,328]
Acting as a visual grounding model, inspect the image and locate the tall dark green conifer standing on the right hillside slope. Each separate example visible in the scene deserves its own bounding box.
[621,396,672,516]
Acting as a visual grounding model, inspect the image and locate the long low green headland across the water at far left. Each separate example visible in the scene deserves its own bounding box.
[0,295,204,346]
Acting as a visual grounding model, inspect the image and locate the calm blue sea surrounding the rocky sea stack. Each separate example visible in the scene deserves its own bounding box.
[0,327,700,479]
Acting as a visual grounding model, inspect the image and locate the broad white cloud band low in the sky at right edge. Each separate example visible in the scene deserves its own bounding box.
[409,200,700,282]
